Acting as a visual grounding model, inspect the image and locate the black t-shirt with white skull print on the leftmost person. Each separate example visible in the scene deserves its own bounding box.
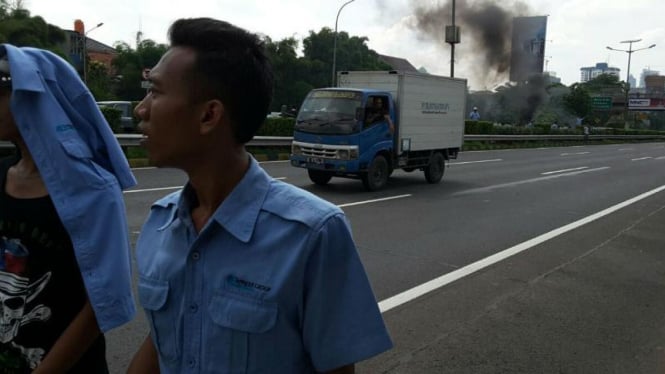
[0,157,108,374]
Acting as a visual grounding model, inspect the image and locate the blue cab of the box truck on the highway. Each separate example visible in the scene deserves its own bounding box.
[291,88,396,190]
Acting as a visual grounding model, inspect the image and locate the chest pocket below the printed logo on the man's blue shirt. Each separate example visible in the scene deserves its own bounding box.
[206,291,278,373]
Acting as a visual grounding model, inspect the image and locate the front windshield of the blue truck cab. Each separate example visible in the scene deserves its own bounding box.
[295,90,362,135]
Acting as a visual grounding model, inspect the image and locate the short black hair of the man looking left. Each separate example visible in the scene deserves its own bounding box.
[169,18,273,144]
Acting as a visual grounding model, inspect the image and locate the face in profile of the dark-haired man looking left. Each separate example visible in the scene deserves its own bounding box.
[134,47,201,168]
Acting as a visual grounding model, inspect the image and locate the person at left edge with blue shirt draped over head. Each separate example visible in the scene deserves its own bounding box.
[0,44,136,374]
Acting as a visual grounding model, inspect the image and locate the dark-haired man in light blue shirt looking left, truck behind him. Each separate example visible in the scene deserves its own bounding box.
[129,18,392,374]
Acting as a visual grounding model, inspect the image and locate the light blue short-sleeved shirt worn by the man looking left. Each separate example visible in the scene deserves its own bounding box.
[137,159,392,373]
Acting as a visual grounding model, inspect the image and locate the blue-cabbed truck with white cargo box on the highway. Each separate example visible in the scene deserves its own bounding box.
[290,71,466,190]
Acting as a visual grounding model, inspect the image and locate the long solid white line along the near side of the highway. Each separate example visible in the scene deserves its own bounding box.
[379,185,665,313]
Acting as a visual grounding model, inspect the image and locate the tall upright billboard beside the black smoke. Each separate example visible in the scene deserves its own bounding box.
[510,16,547,82]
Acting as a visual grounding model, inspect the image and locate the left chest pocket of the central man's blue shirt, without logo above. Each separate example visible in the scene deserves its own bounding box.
[138,277,180,362]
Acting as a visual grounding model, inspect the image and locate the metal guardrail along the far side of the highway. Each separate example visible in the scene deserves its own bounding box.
[0,134,665,149]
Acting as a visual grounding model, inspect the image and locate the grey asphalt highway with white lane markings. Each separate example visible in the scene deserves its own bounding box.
[107,143,665,374]
